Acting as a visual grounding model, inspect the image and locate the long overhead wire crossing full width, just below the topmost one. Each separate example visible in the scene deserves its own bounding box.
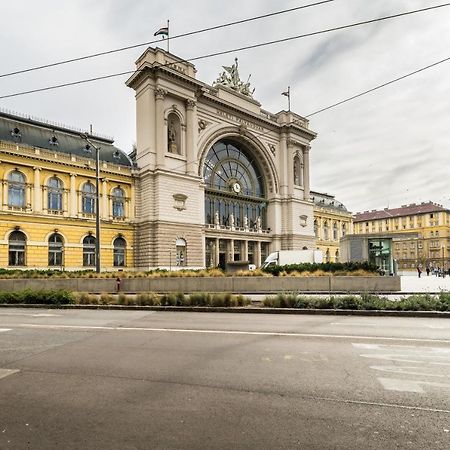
[0,3,450,100]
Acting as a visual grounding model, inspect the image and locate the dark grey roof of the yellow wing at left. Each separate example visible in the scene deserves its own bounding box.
[0,110,133,166]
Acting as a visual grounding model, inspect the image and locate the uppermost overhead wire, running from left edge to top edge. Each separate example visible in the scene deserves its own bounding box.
[0,0,335,78]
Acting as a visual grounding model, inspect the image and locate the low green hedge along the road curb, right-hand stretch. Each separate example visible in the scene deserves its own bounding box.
[263,292,450,311]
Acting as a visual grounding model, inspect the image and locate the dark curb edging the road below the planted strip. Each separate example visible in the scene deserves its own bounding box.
[0,304,450,319]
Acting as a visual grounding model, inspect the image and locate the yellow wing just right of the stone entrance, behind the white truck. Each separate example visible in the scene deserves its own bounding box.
[311,191,352,262]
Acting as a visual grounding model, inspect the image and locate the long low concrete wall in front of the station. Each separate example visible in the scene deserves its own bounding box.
[0,277,400,294]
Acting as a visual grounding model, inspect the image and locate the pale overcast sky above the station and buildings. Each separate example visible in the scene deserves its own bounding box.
[0,0,450,212]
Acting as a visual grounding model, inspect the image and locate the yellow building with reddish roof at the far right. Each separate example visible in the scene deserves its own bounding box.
[353,202,450,271]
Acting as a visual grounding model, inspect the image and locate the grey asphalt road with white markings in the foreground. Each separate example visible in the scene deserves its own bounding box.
[0,309,450,450]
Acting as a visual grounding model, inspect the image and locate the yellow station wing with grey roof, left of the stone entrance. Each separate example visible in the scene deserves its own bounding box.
[0,112,134,270]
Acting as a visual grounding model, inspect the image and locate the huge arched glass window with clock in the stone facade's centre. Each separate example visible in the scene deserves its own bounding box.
[203,140,267,230]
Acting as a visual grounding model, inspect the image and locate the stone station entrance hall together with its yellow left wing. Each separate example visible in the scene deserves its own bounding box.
[0,48,316,270]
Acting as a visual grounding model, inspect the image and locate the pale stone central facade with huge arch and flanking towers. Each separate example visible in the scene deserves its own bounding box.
[127,48,316,269]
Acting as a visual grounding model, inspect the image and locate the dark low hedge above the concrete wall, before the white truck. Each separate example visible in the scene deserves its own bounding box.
[263,261,378,276]
